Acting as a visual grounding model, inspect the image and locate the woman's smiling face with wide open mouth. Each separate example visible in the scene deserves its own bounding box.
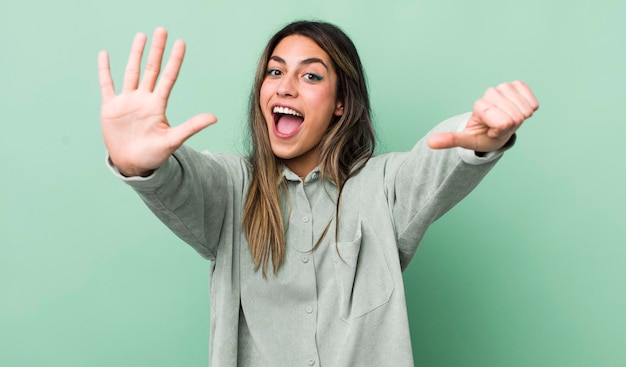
[260,35,343,177]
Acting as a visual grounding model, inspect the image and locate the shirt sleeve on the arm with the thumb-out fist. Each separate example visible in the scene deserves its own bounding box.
[386,114,514,269]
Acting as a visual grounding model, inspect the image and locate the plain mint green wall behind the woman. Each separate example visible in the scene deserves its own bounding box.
[0,0,626,367]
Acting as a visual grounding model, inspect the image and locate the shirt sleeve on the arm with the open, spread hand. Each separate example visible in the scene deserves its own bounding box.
[107,146,232,260]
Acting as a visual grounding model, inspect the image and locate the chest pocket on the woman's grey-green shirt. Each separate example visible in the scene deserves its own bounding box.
[334,222,394,321]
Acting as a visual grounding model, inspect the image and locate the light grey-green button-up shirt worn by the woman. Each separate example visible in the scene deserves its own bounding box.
[112,115,502,367]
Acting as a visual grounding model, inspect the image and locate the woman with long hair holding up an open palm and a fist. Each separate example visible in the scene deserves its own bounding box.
[99,22,538,366]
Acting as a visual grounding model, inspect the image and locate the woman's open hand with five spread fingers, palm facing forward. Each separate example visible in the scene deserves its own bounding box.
[98,28,217,176]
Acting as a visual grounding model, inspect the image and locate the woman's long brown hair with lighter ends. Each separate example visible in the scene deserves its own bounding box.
[242,21,375,276]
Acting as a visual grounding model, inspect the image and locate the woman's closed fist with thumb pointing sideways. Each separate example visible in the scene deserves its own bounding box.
[428,80,539,152]
